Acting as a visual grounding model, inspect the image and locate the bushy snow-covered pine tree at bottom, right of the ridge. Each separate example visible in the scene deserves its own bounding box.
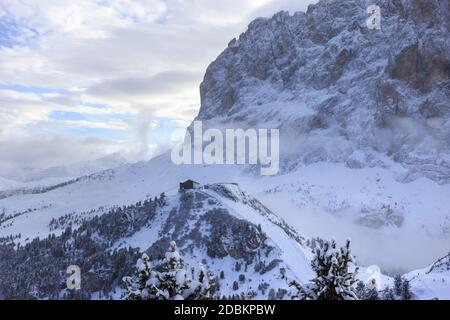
[290,240,358,300]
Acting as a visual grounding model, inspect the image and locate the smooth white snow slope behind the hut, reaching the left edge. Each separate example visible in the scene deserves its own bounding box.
[0,154,243,241]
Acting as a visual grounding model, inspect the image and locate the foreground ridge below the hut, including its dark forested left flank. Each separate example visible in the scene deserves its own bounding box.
[0,184,313,299]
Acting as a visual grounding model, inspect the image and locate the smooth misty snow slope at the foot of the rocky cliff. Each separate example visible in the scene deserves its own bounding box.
[242,163,450,273]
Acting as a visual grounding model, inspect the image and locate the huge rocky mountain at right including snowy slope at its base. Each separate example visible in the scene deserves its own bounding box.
[192,0,450,269]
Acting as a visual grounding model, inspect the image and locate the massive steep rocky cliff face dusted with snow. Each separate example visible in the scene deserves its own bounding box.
[197,0,450,183]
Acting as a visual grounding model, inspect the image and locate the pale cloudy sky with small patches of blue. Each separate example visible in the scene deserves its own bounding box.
[0,0,315,178]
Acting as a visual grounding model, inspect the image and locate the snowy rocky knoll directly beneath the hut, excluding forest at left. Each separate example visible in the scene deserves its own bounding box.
[120,184,313,299]
